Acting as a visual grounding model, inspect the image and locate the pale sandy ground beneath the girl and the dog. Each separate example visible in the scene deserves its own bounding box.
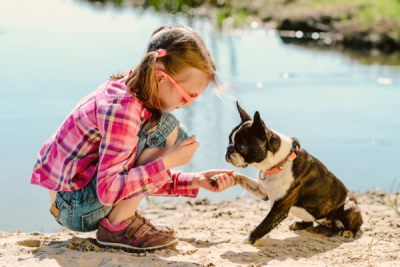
[0,191,400,267]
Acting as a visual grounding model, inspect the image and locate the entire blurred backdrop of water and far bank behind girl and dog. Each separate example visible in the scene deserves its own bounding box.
[0,0,400,232]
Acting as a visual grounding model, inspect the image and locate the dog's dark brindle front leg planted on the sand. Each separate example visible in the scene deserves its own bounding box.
[245,199,291,245]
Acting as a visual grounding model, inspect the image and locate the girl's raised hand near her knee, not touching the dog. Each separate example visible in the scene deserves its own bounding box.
[161,135,200,170]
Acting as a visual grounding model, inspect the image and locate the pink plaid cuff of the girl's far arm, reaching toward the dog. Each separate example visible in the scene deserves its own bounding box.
[152,171,199,198]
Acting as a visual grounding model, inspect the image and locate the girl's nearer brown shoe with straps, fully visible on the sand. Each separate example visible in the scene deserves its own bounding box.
[96,217,178,253]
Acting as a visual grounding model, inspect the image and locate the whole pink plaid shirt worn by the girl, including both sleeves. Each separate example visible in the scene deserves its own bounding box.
[30,76,198,205]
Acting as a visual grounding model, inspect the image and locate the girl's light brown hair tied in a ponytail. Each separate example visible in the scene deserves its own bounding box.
[110,23,218,125]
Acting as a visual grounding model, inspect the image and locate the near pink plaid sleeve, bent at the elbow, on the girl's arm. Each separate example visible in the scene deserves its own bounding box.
[97,98,173,205]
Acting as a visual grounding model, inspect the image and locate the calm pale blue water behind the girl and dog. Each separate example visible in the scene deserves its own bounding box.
[0,0,400,232]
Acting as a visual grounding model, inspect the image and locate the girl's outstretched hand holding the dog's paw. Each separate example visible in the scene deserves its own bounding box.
[193,170,235,193]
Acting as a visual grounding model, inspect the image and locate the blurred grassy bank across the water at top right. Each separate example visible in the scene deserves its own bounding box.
[89,0,400,53]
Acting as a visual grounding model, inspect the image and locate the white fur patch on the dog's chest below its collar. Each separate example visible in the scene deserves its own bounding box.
[258,168,294,207]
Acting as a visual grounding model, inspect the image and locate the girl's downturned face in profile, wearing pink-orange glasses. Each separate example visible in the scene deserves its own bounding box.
[156,67,210,112]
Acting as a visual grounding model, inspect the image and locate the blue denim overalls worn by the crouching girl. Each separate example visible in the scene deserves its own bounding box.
[50,111,189,232]
